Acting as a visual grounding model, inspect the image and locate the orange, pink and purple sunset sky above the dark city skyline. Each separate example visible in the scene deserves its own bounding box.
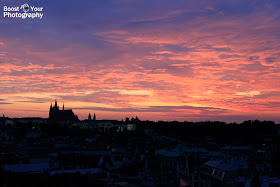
[0,0,280,123]
